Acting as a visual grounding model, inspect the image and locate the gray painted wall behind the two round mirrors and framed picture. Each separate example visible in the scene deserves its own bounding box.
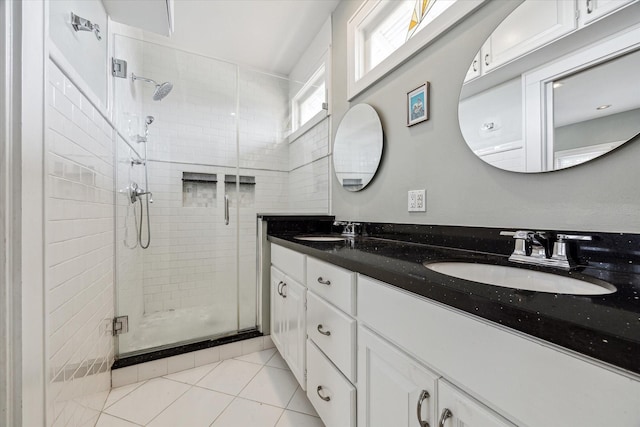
[331,0,640,233]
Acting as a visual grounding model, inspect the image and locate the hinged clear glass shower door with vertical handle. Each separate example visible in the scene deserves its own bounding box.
[114,35,241,357]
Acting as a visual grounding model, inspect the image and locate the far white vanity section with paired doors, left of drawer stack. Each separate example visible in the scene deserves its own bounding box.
[270,244,307,390]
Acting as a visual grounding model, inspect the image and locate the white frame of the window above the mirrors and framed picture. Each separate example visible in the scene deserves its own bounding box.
[347,0,486,101]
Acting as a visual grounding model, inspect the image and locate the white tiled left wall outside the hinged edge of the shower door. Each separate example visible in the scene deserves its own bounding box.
[45,62,115,426]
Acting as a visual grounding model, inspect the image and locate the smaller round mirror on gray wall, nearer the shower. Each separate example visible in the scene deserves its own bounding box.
[333,104,382,191]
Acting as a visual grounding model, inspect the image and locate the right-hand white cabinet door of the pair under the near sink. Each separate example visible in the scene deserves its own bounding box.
[432,380,514,427]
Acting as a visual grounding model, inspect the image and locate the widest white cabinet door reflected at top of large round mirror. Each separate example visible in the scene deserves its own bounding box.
[482,0,577,73]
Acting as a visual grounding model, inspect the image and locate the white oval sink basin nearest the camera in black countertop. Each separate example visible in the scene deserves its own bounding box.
[424,262,616,295]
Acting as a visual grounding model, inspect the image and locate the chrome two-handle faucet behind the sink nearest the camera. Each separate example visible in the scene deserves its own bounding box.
[500,230,593,270]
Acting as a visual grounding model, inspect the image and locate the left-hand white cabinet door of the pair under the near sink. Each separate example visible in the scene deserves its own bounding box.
[358,326,438,427]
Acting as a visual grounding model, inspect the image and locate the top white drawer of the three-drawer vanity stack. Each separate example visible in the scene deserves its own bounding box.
[307,257,356,316]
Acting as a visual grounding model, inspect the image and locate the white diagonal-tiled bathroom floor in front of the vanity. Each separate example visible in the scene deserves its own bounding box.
[96,348,324,427]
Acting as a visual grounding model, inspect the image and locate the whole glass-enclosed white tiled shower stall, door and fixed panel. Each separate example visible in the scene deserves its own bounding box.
[113,35,289,357]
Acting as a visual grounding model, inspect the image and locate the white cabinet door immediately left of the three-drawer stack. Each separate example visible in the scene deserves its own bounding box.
[282,277,307,390]
